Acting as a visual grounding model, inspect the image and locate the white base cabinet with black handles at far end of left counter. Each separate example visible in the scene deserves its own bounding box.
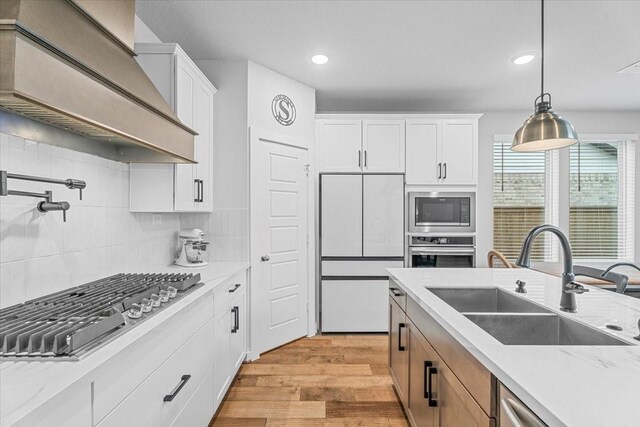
[213,271,248,408]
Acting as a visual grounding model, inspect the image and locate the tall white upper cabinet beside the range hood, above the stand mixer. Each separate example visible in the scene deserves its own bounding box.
[130,43,216,212]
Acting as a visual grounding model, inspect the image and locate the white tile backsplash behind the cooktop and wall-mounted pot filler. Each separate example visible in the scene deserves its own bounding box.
[0,134,180,307]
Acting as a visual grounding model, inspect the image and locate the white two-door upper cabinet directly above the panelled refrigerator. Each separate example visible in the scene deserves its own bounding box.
[316,118,405,173]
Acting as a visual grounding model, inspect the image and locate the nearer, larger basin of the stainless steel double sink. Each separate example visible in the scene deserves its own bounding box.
[465,313,631,346]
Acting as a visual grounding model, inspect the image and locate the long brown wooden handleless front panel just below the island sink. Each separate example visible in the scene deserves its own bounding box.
[407,298,495,416]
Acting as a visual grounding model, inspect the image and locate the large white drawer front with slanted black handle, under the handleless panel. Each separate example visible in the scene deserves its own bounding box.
[98,319,213,427]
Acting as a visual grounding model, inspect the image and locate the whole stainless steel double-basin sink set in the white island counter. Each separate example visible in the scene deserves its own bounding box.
[425,286,631,346]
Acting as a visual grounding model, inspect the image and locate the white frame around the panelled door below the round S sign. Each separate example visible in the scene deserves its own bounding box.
[247,126,318,360]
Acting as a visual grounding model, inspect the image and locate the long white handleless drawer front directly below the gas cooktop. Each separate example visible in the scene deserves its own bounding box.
[93,292,213,421]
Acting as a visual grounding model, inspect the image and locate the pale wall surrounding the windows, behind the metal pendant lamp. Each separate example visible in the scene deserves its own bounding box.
[476,111,640,267]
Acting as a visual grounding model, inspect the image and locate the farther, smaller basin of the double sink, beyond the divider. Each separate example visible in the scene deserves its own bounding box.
[425,286,552,313]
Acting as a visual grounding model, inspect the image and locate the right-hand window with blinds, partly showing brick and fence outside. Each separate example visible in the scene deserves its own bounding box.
[569,140,635,260]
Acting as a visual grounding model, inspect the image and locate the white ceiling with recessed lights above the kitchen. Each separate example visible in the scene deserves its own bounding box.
[136,0,640,112]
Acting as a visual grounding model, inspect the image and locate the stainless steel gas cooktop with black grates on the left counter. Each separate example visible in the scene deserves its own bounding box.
[0,273,203,360]
